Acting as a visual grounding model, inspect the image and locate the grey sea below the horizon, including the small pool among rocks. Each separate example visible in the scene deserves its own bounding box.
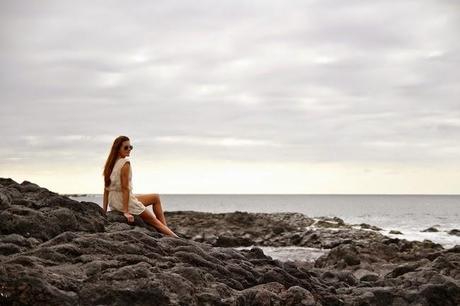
[70,194,460,261]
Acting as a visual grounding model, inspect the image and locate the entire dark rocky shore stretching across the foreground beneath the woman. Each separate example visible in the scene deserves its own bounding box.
[0,178,460,306]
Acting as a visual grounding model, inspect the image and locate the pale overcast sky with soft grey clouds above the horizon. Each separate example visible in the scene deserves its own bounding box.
[0,0,460,194]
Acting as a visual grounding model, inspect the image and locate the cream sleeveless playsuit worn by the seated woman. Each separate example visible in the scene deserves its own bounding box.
[106,157,145,215]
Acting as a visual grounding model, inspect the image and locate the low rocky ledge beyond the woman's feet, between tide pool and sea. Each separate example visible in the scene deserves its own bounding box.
[165,211,383,249]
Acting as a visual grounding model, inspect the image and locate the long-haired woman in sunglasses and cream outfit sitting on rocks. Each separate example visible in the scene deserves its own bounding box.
[103,136,179,238]
